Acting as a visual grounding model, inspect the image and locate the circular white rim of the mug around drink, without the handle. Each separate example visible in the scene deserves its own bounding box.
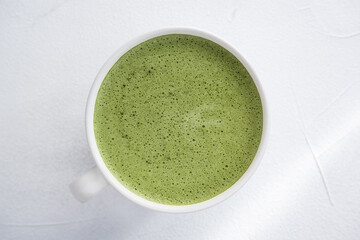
[85,27,270,213]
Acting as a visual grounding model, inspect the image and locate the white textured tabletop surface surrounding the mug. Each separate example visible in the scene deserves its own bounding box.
[0,0,360,240]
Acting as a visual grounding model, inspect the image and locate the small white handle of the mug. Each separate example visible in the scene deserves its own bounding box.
[69,166,109,202]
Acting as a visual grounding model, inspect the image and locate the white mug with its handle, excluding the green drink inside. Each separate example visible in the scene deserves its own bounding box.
[70,28,269,213]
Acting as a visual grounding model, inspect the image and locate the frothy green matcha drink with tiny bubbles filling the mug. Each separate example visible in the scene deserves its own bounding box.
[94,34,263,205]
